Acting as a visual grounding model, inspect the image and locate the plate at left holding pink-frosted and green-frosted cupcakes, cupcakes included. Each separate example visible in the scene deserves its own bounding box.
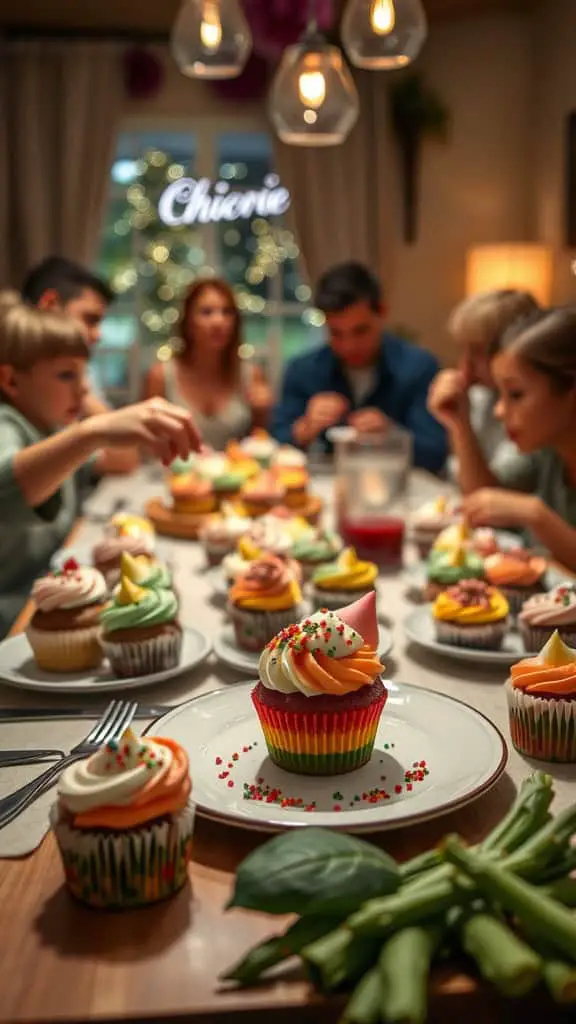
[0,552,211,693]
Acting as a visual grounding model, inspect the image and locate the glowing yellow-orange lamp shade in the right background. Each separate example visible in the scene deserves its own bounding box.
[466,243,552,306]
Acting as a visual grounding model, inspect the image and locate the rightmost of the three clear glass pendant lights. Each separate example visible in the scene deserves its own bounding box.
[342,0,427,71]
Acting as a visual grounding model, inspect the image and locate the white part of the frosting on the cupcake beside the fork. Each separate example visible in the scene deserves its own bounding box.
[58,729,172,814]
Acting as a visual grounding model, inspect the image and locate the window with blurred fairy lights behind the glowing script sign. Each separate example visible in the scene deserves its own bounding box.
[96,129,323,399]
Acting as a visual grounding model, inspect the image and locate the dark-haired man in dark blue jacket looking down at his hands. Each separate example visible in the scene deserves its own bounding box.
[273,263,448,473]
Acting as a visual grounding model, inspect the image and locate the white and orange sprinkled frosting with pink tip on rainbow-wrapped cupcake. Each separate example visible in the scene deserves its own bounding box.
[259,594,383,697]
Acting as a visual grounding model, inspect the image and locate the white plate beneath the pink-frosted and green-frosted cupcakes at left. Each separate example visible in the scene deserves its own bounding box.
[0,630,212,693]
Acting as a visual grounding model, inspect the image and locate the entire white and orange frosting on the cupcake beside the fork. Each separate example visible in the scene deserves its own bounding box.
[58,729,192,828]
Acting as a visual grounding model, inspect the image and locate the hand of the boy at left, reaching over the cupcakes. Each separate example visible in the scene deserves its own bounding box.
[84,398,201,464]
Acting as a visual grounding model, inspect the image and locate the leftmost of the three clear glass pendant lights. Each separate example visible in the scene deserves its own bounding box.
[170,0,252,79]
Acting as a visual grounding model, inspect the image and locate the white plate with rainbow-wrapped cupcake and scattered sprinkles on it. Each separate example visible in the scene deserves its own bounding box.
[148,592,507,831]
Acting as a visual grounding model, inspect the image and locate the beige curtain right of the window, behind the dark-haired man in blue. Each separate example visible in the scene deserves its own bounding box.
[276,72,399,290]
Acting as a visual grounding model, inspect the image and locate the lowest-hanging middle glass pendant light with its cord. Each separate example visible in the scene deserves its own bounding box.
[270,0,360,145]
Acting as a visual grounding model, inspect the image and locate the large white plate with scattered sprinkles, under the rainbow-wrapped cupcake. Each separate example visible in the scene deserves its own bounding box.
[148,682,507,831]
